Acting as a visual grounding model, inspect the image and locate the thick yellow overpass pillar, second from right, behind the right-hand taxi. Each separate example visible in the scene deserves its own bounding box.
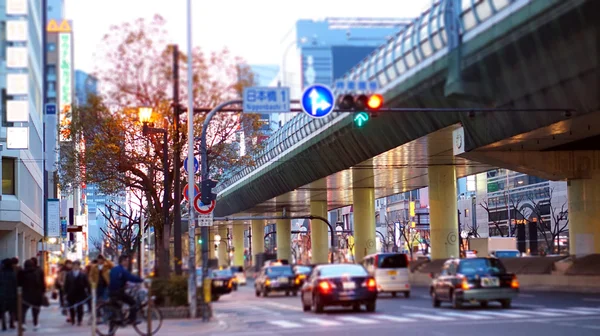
[427,166,459,259]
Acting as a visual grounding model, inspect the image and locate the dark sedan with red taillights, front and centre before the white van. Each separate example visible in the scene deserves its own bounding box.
[301,264,377,313]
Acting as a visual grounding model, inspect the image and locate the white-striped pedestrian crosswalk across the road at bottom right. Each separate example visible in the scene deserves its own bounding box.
[266,307,600,329]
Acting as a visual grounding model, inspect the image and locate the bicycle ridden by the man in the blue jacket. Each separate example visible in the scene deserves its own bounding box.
[96,285,163,336]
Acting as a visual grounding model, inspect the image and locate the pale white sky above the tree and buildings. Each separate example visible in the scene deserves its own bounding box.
[65,0,432,72]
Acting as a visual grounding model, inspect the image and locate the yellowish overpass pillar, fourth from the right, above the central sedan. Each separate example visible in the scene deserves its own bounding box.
[310,200,329,264]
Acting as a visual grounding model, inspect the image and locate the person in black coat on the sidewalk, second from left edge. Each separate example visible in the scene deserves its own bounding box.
[17,259,46,330]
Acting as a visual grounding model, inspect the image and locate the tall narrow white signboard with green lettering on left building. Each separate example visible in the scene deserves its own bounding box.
[58,33,73,141]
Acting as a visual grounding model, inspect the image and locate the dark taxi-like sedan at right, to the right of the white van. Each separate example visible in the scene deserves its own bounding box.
[430,258,519,308]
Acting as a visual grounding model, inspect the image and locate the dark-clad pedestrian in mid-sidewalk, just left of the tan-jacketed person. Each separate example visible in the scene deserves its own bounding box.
[65,261,90,326]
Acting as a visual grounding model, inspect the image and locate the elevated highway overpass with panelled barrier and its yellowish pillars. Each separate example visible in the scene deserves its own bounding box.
[209,0,600,262]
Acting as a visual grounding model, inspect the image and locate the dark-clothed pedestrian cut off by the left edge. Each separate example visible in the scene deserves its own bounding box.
[0,259,17,331]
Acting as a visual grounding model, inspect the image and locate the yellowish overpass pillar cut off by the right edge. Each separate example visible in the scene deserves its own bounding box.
[567,172,600,256]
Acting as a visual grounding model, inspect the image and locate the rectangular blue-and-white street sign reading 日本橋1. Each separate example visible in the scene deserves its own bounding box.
[243,87,291,113]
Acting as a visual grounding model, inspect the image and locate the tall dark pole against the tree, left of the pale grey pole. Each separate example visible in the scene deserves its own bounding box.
[173,45,183,275]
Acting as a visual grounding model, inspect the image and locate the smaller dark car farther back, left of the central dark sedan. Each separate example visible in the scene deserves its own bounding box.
[254,265,298,297]
